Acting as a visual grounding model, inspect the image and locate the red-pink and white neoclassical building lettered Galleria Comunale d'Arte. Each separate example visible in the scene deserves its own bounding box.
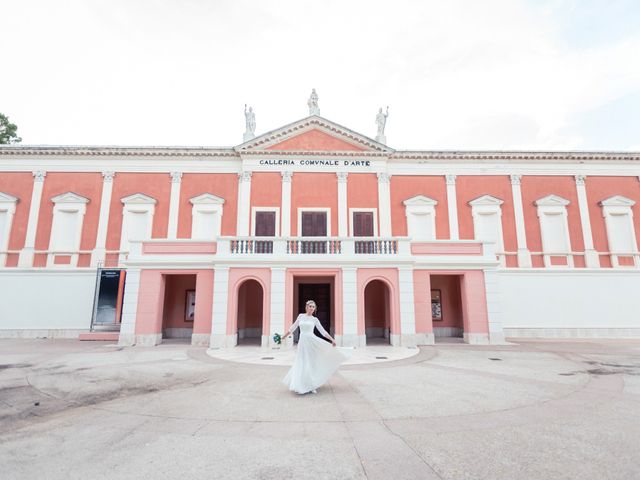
[0,110,640,347]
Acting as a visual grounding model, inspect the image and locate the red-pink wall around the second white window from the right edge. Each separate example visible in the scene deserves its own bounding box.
[521,175,584,267]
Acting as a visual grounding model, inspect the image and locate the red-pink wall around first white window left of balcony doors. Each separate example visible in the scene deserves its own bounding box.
[176,173,238,238]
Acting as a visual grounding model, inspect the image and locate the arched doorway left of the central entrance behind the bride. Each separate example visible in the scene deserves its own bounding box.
[236,280,264,345]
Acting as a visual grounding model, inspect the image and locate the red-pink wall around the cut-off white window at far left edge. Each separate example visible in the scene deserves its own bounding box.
[0,172,33,267]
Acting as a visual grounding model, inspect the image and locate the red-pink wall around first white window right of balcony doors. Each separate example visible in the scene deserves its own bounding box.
[391,175,449,240]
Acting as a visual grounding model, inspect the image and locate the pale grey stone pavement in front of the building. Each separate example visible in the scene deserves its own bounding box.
[0,339,640,480]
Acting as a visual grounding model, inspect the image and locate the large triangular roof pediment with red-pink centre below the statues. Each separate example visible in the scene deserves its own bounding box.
[235,115,393,153]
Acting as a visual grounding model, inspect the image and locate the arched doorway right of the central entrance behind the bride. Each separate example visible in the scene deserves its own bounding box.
[364,280,391,345]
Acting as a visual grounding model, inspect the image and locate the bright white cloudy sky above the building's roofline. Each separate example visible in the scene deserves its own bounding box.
[0,0,640,150]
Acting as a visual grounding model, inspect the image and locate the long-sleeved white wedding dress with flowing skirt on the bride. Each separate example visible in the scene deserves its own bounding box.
[282,313,353,393]
